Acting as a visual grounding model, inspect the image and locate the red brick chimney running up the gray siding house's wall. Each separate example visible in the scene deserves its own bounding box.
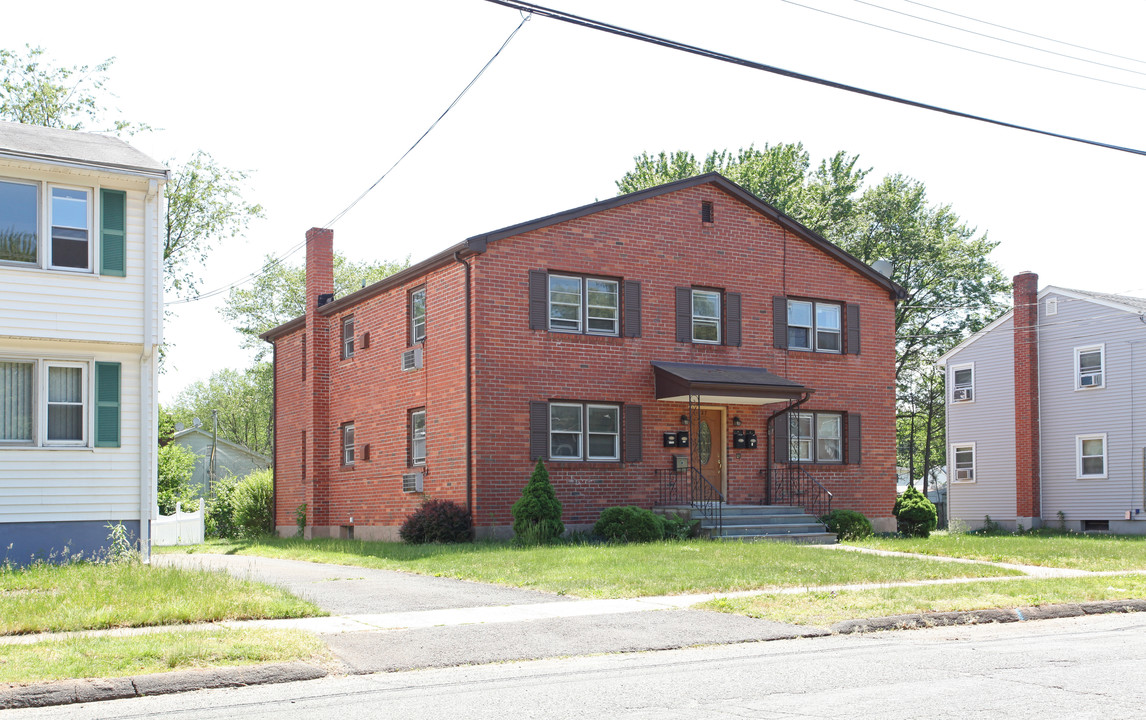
[1013,271,1042,529]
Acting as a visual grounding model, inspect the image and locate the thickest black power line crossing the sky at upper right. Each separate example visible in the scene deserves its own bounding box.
[486,0,1146,156]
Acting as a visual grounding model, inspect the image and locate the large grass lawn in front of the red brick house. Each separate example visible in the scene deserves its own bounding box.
[159,538,1018,597]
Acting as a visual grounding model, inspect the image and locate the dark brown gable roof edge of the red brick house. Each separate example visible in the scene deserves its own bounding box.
[259,172,906,342]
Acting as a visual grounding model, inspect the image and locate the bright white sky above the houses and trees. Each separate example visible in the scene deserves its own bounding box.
[0,0,1146,402]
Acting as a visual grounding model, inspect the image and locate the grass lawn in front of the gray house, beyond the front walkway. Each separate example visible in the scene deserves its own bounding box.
[847,531,1146,571]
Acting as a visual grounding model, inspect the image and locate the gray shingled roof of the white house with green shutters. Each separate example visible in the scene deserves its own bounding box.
[0,122,167,178]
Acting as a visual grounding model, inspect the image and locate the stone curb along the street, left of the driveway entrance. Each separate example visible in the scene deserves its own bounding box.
[0,662,328,710]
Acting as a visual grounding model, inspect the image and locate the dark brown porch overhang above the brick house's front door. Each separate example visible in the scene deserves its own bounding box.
[652,361,815,405]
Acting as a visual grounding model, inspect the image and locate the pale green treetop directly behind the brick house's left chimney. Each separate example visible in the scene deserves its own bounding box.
[219,252,410,360]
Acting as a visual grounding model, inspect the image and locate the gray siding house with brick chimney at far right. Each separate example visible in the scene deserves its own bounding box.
[939,273,1146,534]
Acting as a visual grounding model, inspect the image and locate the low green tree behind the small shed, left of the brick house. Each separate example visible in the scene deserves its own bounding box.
[168,362,274,455]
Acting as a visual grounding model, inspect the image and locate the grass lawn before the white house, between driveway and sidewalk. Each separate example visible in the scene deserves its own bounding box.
[0,563,325,635]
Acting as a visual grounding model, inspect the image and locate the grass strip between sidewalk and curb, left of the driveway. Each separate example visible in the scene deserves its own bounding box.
[0,628,329,683]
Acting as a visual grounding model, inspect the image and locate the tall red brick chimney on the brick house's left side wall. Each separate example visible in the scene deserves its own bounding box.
[304,227,338,537]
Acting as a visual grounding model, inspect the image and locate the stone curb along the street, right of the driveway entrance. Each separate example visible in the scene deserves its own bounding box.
[829,600,1146,635]
